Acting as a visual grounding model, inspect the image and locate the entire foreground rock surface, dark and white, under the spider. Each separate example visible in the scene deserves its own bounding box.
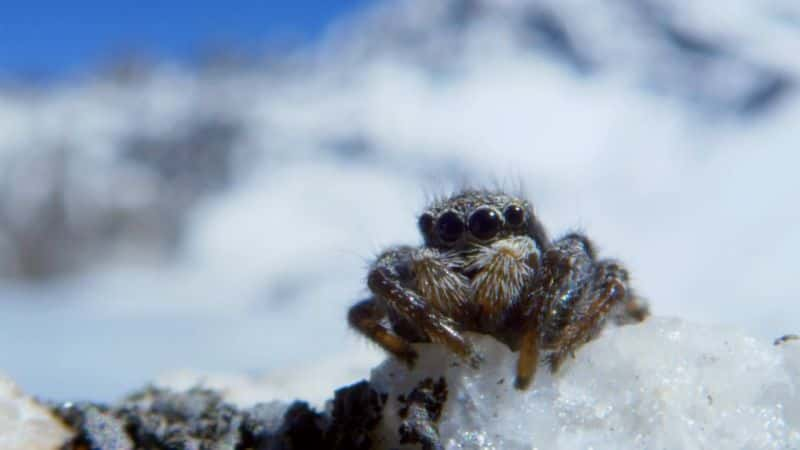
[0,318,800,450]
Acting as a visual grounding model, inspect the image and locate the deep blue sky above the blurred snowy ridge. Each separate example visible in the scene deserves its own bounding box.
[0,0,376,75]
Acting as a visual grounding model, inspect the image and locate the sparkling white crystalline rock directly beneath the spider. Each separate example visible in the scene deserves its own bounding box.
[372,318,800,450]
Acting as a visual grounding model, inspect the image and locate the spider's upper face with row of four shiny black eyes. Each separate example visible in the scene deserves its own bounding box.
[418,191,532,250]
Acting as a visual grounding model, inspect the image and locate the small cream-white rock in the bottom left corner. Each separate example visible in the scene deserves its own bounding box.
[0,375,72,450]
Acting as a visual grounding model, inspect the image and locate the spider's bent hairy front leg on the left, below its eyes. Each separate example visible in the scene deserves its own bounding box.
[367,247,482,368]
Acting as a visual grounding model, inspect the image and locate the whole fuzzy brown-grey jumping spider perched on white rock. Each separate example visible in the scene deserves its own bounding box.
[348,190,648,389]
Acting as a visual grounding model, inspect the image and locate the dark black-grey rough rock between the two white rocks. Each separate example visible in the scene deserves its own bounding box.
[52,381,394,450]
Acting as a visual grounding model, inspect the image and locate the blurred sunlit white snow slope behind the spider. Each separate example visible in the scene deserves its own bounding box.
[0,1,800,400]
